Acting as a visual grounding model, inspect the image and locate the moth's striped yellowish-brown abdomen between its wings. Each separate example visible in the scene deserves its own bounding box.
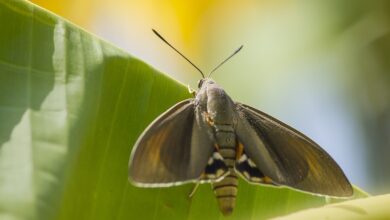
[212,125,238,215]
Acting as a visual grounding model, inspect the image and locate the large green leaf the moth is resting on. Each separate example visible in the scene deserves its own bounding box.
[0,0,370,220]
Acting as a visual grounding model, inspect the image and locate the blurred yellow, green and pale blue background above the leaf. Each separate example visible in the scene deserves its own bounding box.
[32,0,390,194]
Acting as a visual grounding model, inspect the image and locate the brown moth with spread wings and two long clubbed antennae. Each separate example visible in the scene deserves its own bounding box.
[129,30,353,215]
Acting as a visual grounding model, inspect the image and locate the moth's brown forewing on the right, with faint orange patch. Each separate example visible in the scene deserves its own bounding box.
[236,103,353,196]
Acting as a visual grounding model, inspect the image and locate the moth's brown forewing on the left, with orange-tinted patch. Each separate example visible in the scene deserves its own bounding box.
[129,99,213,187]
